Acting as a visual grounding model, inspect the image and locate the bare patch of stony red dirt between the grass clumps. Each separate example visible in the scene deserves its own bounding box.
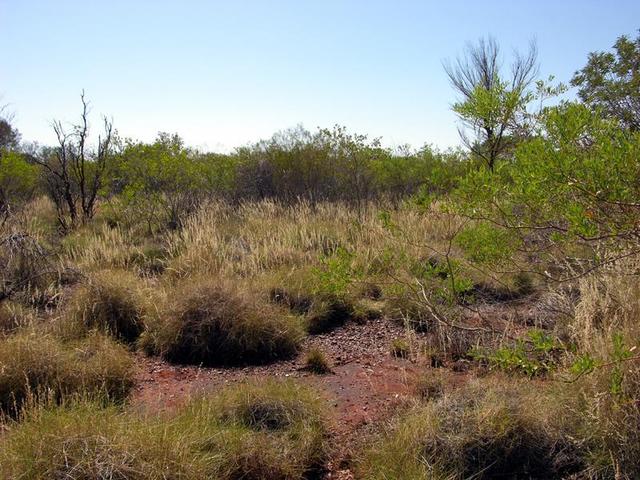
[133,319,424,479]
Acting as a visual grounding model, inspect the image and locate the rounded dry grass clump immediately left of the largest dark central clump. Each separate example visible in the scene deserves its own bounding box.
[59,270,150,343]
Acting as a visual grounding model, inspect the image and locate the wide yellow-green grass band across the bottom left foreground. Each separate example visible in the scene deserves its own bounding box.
[0,382,327,480]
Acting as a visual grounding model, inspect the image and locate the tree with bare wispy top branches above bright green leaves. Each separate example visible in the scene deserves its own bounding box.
[444,37,538,170]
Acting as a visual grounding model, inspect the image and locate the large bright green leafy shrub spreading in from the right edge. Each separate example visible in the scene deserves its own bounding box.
[456,103,640,279]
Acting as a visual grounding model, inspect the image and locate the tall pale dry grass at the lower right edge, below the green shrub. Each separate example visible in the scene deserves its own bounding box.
[559,256,640,479]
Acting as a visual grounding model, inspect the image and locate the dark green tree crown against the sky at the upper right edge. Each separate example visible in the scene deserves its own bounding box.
[571,31,640,131]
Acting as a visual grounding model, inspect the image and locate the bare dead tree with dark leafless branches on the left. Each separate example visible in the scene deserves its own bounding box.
[35,91,113,231]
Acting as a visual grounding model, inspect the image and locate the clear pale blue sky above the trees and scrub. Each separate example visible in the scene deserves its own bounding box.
[0,0,640,150]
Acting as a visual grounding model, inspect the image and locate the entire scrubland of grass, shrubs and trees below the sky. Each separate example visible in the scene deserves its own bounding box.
[0,32,640,480]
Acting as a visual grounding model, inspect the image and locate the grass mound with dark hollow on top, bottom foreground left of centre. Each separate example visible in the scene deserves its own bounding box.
[201,381,328,480]
